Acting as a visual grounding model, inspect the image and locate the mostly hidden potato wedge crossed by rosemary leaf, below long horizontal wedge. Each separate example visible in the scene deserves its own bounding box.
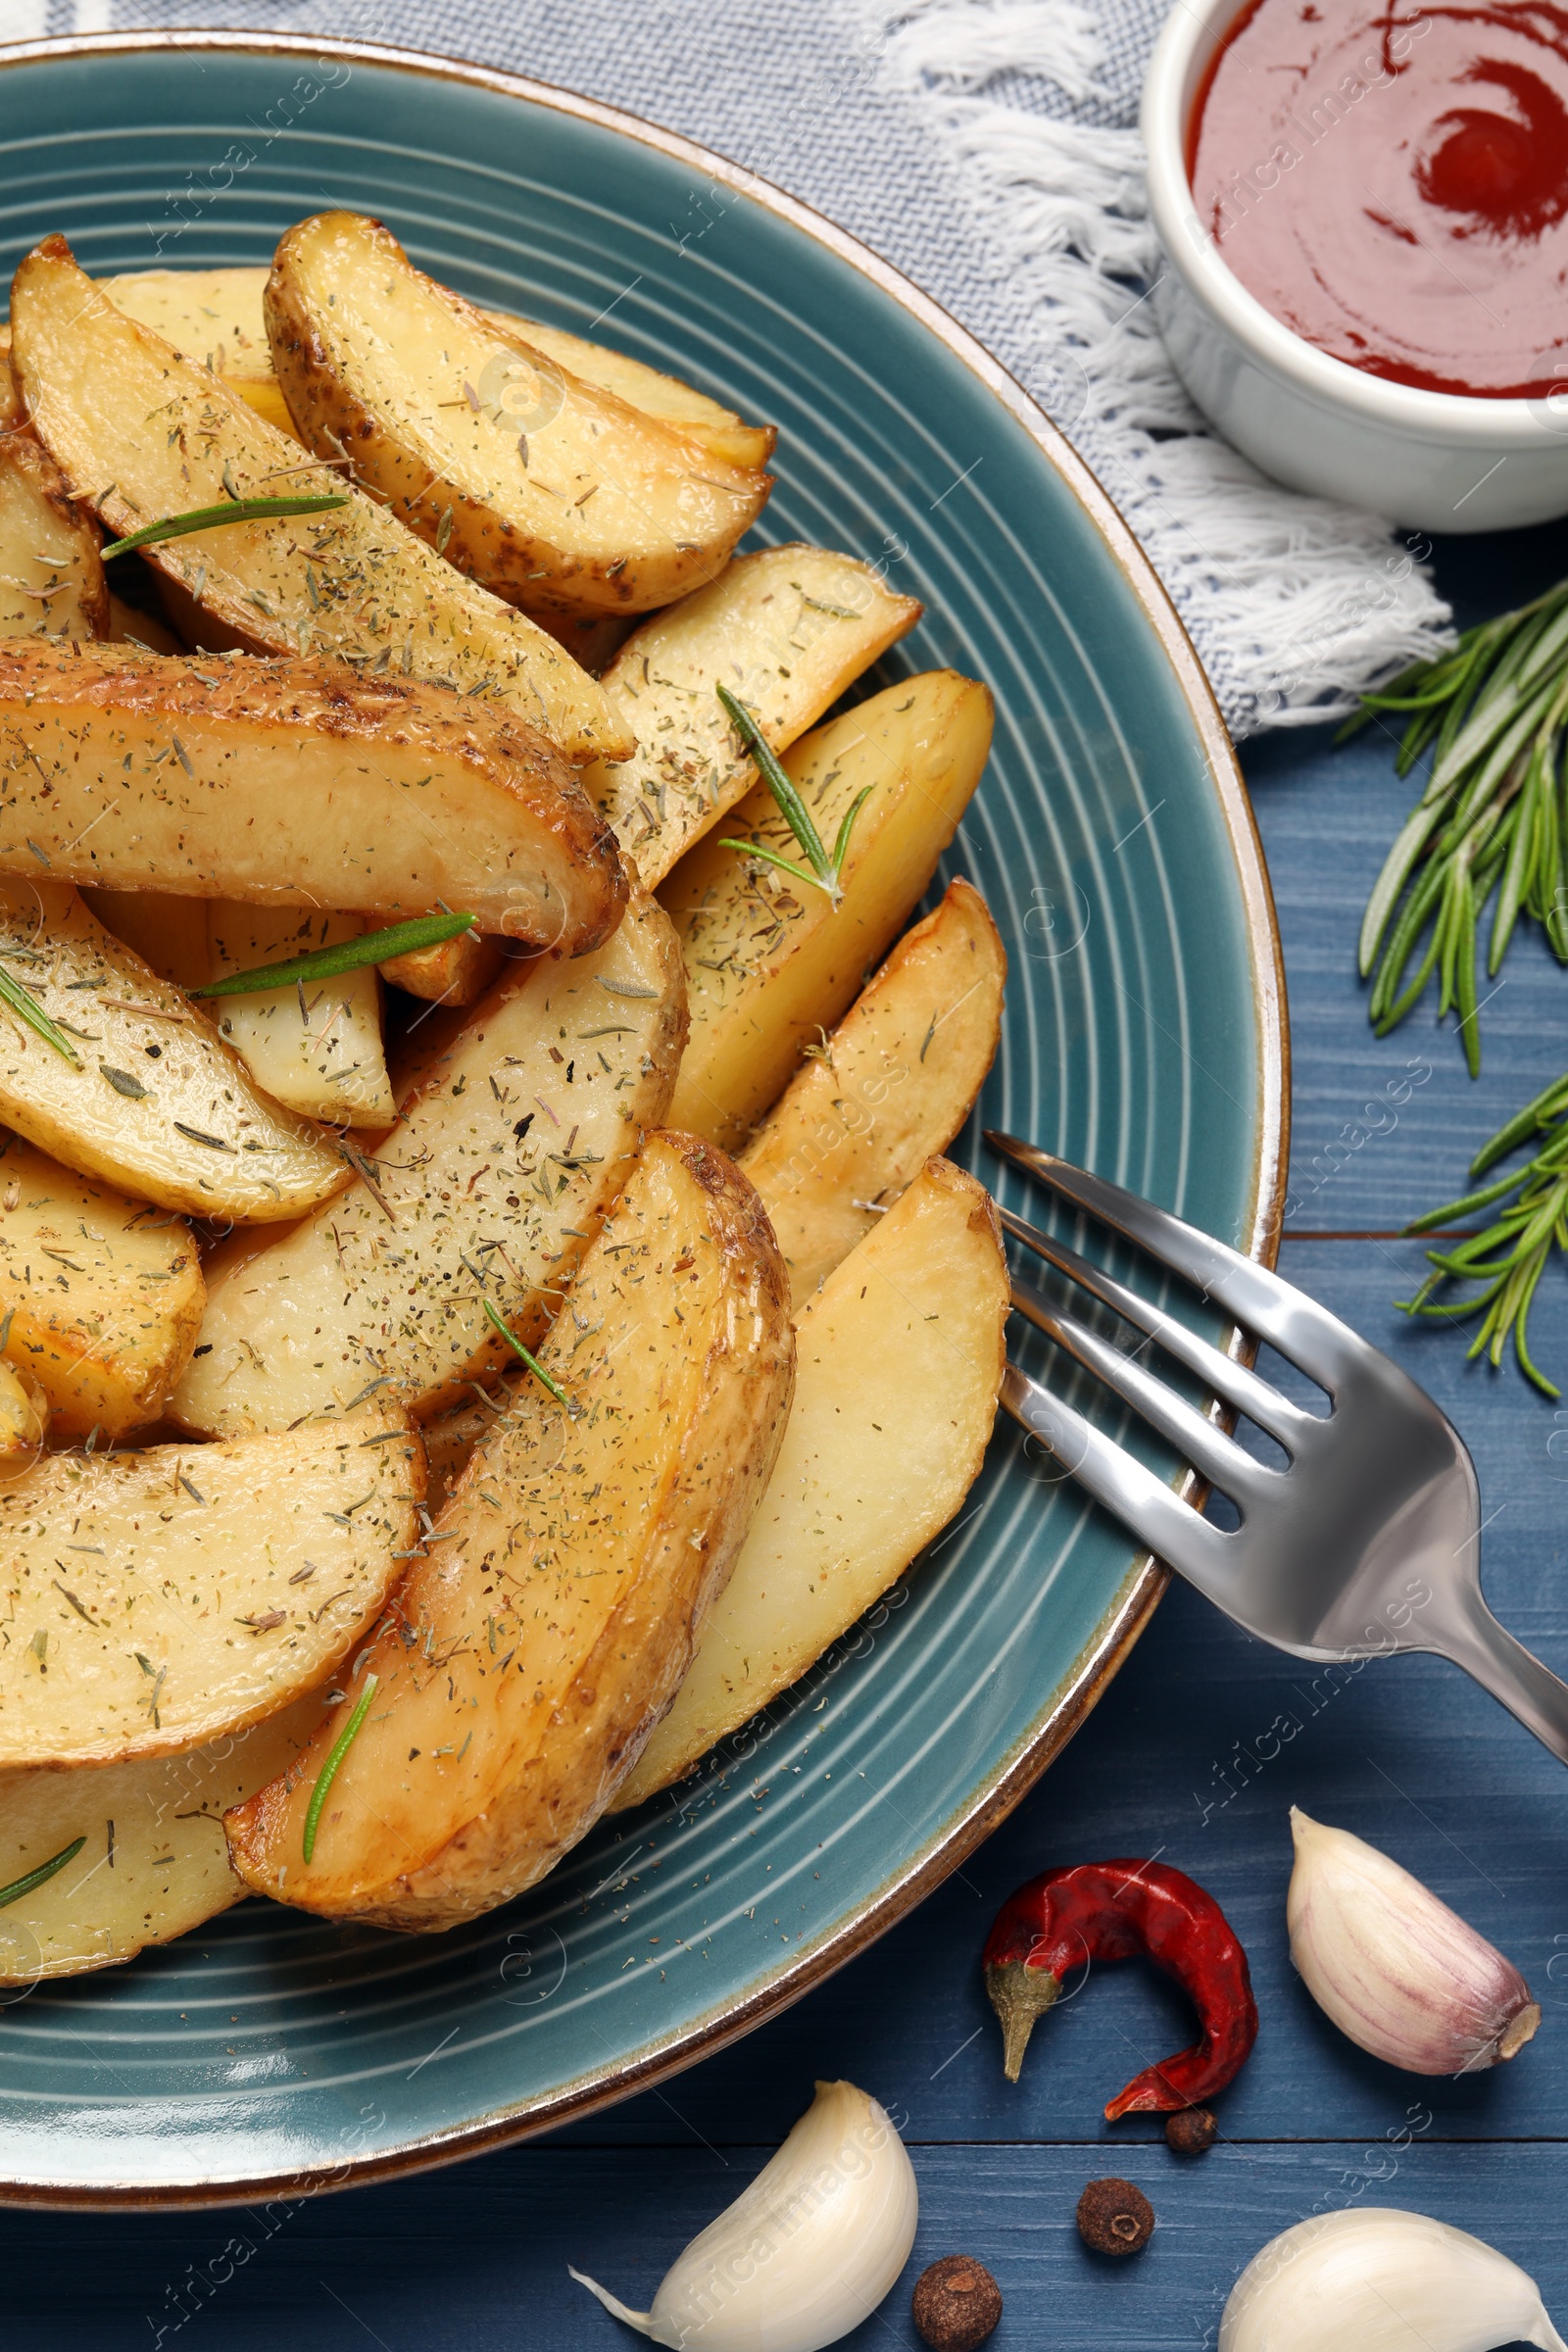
[207,899,395,1127]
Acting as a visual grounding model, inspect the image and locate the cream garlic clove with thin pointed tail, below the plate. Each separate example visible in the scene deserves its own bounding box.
[571,2082,919,2352]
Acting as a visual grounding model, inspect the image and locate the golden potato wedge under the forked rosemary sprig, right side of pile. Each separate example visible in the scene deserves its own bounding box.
[659,670,992,1151]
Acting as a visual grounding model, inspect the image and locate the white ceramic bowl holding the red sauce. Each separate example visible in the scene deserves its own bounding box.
[1143,0,1568,531]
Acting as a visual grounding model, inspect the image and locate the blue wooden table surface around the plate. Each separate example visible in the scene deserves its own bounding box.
[0,529,1568,2352]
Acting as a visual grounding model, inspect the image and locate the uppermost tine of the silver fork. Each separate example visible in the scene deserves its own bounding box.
[985,1127,1373,1395]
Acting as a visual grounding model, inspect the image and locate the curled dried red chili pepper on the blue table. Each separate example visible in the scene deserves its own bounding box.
[985,1863,1257,2124]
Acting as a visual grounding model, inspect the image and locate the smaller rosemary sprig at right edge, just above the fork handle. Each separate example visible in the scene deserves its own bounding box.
[1398,1077,1568,1397]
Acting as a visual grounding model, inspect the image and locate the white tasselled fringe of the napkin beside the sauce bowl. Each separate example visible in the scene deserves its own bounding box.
[867,0,1452,736]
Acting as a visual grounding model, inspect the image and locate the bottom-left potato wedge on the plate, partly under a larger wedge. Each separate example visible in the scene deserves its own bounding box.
[0,1691,324,1985]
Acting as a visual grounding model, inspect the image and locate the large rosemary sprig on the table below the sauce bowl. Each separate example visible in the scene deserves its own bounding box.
[1340,581,1568,1077]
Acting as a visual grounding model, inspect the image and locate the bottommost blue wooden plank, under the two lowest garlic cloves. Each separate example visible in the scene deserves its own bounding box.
[5,2144,1568,2352]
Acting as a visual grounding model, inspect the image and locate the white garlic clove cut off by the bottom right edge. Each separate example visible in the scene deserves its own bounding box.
[1220,2206,1568,2352]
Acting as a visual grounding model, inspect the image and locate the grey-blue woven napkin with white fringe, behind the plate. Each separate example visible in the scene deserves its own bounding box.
[18,0,1448,734]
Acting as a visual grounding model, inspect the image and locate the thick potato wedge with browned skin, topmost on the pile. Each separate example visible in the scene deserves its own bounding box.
[264,212,773,613]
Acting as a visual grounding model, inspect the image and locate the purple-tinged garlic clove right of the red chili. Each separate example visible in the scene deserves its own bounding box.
[1286,1806,1540,2075]
